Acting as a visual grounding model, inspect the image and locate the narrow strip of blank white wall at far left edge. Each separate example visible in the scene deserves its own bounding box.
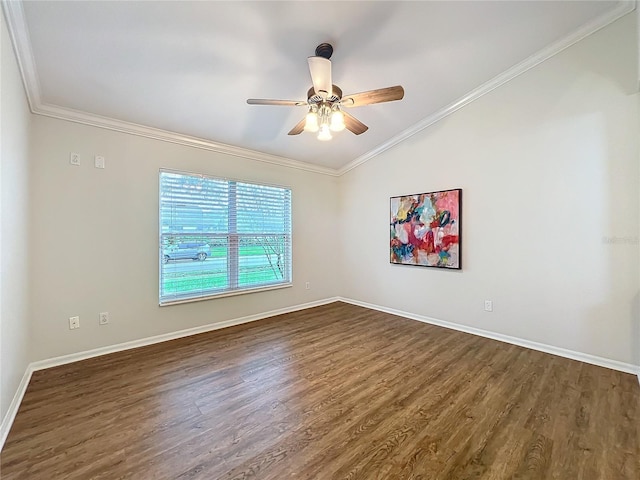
[0,15,31,422]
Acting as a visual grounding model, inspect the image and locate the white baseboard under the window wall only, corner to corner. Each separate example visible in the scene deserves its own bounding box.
[30,297,338,371]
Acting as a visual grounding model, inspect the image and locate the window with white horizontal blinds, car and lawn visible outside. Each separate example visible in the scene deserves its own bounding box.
[160,170,291,305]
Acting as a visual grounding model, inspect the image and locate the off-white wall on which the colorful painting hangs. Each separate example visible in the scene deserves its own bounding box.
[340,15,640,365]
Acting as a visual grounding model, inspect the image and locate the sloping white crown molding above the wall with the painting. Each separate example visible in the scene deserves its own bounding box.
[338,0,640,176]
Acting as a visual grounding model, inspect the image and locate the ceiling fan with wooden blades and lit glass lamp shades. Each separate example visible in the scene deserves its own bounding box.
[247,43,404,140]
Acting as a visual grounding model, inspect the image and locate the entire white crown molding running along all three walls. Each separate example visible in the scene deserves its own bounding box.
[5,0,640,177]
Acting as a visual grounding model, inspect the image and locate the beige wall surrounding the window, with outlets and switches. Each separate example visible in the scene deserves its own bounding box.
[31,116,338,360]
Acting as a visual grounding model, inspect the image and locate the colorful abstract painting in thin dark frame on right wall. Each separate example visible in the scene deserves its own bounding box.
[390,189,462,269]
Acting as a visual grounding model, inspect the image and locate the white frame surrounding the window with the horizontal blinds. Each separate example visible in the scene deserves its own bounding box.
[157,168,293,307]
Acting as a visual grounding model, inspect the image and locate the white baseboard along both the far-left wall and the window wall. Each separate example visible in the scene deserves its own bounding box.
[0,297,339,451]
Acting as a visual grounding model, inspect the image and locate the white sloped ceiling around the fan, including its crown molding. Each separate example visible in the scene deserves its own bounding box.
[5,1,633,171]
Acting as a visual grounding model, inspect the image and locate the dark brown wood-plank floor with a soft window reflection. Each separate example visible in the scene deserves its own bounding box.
[1,303,640,480]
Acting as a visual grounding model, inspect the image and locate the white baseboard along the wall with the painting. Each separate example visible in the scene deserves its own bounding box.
[339,297,640,380]
